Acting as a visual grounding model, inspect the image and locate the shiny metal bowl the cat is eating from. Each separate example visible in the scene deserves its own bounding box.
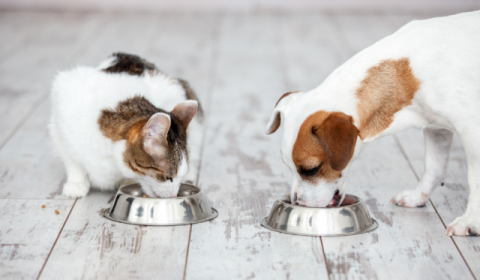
[103,184,218,226]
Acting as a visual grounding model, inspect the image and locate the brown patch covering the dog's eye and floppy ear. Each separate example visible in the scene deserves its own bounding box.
[292,111,358,183]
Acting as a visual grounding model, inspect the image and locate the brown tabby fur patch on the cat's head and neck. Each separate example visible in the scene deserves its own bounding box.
[98,96,188,181]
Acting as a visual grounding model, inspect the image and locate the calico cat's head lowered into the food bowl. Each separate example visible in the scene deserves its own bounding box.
[123,100,198,197]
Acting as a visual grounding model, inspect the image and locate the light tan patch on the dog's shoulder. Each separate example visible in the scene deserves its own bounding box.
[356,58,420,139]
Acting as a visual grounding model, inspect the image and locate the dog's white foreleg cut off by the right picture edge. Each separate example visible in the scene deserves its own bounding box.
[445,130,480,236]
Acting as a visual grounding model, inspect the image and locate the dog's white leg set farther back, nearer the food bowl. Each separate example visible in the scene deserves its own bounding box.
[390,128,453,207]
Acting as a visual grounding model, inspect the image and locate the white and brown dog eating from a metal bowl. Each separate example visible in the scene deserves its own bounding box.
[266,11,480,235]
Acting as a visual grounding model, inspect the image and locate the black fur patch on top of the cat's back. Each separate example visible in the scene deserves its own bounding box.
[103,53,156,76]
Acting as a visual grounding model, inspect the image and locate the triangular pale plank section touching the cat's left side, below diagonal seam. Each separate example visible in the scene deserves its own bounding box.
[0,100,65,199]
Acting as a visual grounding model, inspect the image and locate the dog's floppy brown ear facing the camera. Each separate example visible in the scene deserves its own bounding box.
[312,112,359,171]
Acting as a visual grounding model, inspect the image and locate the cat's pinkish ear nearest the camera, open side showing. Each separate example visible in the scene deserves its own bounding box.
[142,113,171,155]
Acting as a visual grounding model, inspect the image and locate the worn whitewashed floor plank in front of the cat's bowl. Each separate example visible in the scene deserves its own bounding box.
[40,191,190,279]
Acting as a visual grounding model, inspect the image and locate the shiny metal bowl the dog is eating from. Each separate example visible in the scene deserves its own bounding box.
[262,195,378,236]
